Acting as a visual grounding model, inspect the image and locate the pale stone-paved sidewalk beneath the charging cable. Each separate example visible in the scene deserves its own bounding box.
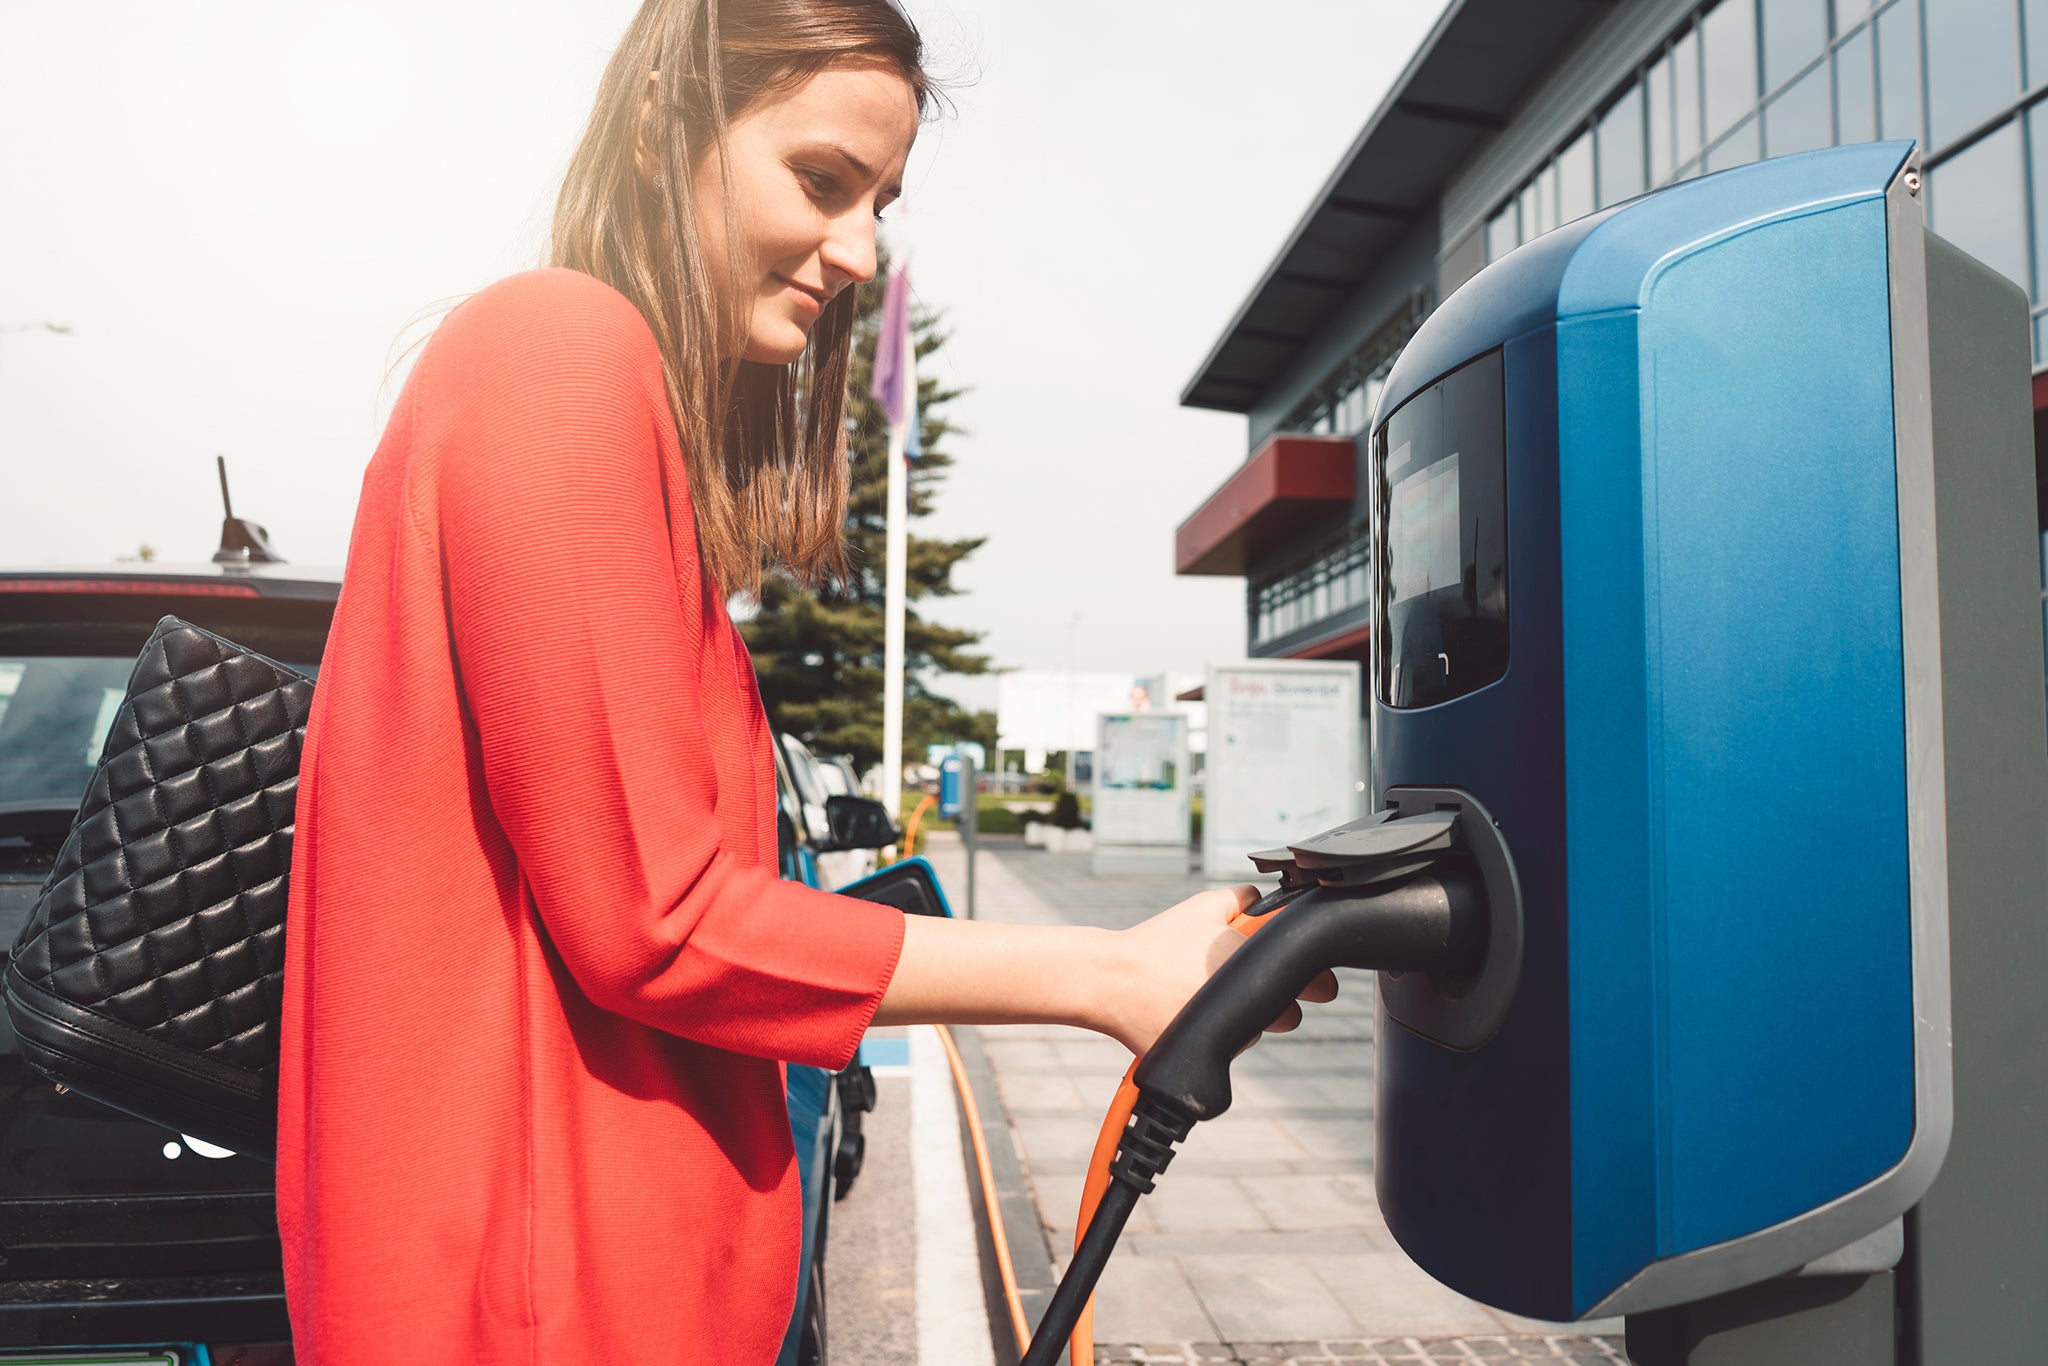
[928,834,1626,1366]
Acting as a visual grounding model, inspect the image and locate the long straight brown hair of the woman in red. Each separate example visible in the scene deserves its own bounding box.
[551,0,932,594]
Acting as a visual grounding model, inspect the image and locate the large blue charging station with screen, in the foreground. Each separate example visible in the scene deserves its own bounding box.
[1372,143,2048,1360]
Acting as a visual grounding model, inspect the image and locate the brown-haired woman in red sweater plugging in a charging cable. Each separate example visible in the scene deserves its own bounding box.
[279,0,1327,1366]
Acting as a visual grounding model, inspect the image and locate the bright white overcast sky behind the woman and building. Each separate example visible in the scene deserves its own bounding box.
[0,0,1444,700]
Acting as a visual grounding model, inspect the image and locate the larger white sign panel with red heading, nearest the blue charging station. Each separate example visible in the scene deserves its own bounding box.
[1202,659,1366,883]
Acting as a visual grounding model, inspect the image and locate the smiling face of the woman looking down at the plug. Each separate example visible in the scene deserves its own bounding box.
[690,59,918,365]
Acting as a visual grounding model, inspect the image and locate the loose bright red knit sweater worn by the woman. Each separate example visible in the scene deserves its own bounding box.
[276,270,903,1366]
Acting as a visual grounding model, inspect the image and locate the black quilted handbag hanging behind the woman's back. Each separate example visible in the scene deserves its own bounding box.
[6,616,313,1159]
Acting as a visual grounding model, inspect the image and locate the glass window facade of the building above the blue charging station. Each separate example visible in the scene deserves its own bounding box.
[1485,0,2048,365]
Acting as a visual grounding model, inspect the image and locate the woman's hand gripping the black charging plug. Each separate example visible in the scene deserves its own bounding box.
[1094,885,1337,1057]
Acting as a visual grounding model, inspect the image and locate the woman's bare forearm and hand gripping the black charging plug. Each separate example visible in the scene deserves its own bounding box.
[874,887,1337,1053]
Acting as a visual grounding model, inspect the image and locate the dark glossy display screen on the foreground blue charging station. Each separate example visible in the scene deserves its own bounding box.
[1374,352,1507,707]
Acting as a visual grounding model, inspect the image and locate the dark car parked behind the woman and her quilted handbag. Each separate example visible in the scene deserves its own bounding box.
[0,548,872,1366]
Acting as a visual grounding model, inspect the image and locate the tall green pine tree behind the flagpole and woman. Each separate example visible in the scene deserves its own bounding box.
[739,262,995,770]
